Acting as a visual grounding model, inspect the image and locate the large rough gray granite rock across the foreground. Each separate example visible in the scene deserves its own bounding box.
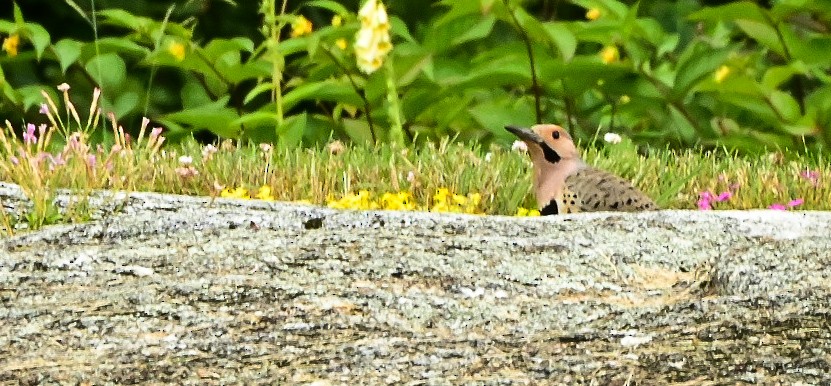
[0,185,831,385]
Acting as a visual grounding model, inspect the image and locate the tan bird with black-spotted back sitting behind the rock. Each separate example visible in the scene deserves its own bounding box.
[505,124,658,216]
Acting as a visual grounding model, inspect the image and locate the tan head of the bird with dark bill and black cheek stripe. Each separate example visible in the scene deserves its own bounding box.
[505,124,580,164]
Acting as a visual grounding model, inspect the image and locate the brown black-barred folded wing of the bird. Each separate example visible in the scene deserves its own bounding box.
[566,167,658,212]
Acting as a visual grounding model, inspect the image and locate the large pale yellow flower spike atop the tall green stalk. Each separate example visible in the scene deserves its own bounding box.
[355,0,392,74]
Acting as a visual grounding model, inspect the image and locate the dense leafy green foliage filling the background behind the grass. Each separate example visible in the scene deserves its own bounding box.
[0,0,831,152]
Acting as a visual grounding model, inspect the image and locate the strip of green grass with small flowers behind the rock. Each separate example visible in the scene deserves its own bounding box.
[0,87,831,232]
